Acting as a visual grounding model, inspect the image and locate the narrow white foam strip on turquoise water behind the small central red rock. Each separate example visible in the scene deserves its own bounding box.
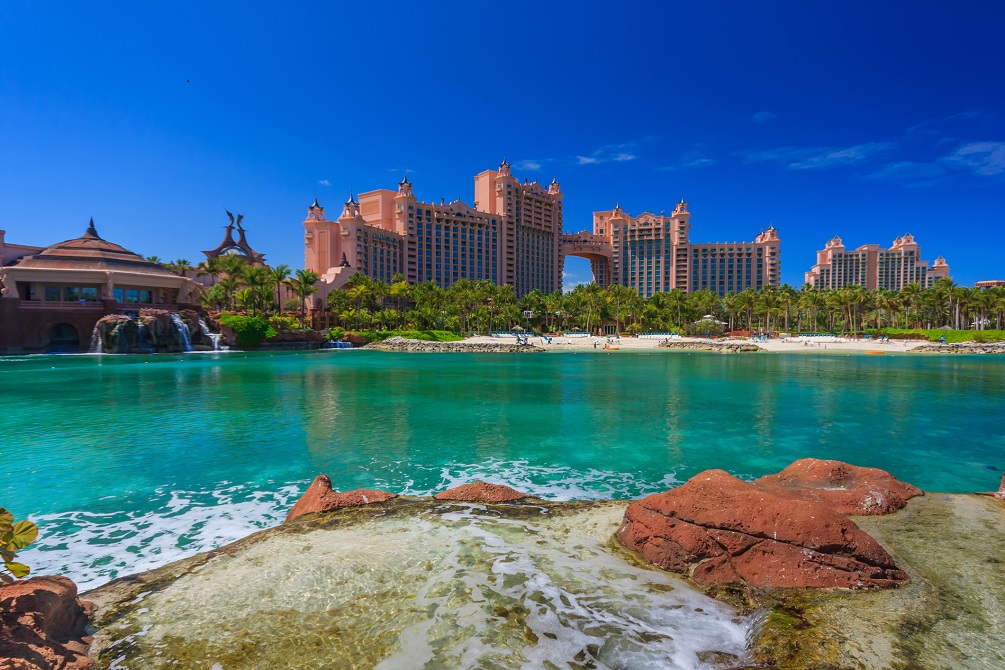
[375,458,682,500]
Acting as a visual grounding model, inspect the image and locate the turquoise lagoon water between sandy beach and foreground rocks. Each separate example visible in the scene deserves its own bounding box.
[0,351,1005,587]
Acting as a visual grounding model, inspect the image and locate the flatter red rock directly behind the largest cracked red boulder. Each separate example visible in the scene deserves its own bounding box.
[754,458,925,514]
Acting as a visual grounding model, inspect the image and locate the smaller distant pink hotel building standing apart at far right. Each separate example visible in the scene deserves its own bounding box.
[806,233,949,290]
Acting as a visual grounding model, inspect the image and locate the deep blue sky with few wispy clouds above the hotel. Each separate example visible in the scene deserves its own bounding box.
[0,0,1005,287]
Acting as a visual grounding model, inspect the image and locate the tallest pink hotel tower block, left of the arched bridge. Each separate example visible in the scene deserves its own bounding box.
[304,160,562,295]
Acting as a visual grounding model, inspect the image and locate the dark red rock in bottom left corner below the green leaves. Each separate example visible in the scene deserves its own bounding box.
[0,577,93,670]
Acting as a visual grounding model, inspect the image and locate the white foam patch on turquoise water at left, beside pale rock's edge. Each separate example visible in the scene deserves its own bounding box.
[18,483,304,592]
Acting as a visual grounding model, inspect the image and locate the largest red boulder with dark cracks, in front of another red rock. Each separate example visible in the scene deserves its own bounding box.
[618,470,908,588]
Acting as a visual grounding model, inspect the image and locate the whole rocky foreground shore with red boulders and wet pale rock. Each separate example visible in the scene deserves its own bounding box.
[0,459,1005,670]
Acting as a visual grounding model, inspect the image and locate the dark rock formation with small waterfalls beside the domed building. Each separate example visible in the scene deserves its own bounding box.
[90,309,216,354]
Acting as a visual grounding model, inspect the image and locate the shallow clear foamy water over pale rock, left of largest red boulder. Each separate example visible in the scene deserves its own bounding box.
[95,504,753,670]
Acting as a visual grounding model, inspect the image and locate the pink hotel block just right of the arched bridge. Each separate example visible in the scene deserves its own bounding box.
[567,200,781,297]
